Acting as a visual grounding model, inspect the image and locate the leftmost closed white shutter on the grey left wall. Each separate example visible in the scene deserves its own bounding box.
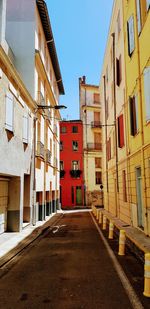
[5,92,14,131]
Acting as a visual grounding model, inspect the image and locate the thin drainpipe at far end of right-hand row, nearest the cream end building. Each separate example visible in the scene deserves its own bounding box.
[103,75,109,211]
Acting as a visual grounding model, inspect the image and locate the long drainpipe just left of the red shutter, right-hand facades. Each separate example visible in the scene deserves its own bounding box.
[112,33,119,216]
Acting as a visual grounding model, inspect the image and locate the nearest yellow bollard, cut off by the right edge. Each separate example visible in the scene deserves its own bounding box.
[143,253,150,297]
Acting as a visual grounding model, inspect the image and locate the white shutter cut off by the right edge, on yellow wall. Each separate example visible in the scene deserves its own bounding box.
[144,67,150,120]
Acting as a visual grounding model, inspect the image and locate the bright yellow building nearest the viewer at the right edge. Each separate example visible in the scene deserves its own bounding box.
[123,0,150,235]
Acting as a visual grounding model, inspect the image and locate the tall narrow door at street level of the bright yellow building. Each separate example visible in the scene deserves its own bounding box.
[136,167,144,228]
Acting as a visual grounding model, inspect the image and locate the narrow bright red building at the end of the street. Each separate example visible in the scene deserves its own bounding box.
[60,120,84,208]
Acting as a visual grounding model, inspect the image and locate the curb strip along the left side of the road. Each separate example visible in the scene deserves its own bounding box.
[0,214,63,268]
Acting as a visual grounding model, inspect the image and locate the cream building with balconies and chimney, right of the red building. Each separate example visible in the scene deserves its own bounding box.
[79,76,102,206]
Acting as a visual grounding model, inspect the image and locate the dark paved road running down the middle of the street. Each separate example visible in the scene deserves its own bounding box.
[0,212,142,309]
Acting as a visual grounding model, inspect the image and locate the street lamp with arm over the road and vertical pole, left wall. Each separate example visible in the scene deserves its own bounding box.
[32,105,67,225]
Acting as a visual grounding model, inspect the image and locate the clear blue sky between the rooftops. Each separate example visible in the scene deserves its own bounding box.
[46,0,113,120]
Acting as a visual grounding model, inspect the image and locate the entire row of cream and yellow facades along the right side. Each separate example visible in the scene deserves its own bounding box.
[100,0,150,235]
